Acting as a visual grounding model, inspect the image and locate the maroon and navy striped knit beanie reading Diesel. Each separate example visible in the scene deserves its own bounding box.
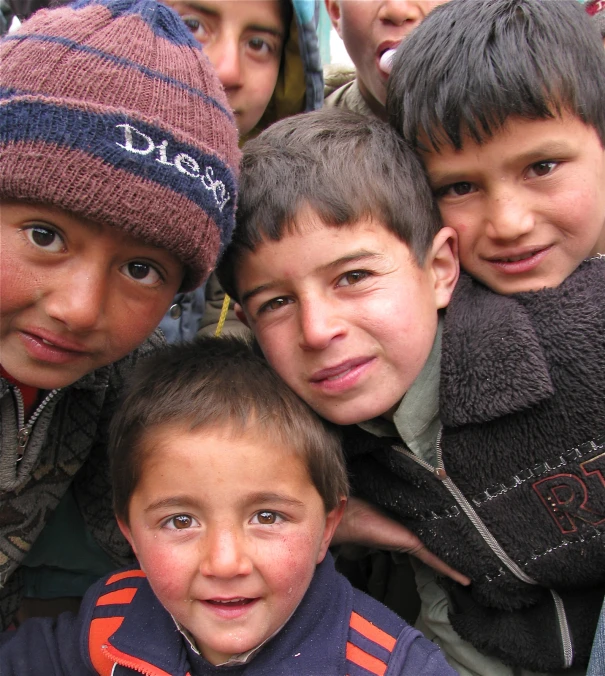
[0,0,240,291]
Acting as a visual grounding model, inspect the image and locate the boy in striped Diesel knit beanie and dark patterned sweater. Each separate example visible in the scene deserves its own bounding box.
[0,0,239,626]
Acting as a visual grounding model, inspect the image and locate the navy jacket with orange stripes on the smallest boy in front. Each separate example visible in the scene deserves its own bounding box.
[0,555,455,676]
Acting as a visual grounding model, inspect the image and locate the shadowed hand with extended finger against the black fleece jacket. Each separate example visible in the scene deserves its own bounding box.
[332,498,471,586]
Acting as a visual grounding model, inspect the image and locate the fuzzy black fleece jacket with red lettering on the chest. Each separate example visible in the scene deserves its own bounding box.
[345,259,605,671]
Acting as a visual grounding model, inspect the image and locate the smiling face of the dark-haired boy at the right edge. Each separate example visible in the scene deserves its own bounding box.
[422,113,605,294]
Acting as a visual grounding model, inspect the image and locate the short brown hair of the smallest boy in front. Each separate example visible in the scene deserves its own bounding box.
[109,336,348,523]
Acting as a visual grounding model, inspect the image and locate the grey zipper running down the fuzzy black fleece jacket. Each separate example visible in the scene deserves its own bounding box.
[394,430,573,668]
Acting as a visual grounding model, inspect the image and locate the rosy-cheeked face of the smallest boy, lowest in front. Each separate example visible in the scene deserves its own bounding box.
[120,426,342,665]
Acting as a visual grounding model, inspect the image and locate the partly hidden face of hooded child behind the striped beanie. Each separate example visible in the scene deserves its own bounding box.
[167,0,285,136]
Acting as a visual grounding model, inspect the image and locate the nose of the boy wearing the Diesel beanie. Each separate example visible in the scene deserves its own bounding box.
[46,261,109,332]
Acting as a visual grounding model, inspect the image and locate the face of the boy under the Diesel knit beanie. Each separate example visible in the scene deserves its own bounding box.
[0,202,183,389]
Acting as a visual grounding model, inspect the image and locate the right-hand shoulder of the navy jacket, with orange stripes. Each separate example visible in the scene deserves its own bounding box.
[346,590,456,676]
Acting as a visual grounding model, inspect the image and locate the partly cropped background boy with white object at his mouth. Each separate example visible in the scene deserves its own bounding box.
[325,0,447,120]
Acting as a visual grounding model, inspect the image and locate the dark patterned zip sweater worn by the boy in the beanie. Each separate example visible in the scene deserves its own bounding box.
[0,333,164,628]
